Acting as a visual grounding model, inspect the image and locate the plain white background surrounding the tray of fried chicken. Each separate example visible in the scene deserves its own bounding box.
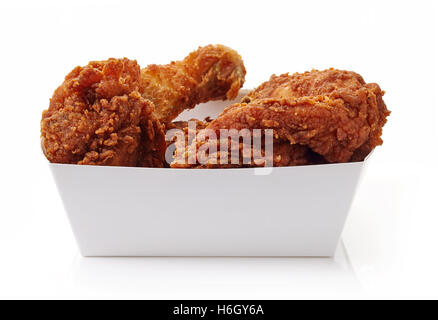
[0,0,438,299]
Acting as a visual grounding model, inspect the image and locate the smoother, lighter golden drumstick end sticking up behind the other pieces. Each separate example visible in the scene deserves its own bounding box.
[140,45,246,124]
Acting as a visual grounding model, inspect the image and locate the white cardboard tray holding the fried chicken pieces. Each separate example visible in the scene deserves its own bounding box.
[50,92,366,256]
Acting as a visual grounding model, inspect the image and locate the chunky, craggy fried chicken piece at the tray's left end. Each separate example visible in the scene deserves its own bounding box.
[41,58,165,166]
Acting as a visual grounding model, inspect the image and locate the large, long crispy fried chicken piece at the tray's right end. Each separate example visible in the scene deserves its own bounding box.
[172,69,390,167]
